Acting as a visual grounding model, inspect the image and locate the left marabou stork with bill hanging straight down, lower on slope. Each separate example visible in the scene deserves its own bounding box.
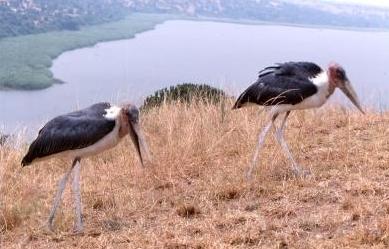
[21,103,149,233]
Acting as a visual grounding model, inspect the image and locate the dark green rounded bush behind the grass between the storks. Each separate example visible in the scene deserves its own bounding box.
[141,83,227,109]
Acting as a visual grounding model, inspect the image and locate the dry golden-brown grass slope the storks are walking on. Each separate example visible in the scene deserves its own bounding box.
[0,100,389,249]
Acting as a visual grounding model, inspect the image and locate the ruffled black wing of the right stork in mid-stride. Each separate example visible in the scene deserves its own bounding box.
[233,62,322,109]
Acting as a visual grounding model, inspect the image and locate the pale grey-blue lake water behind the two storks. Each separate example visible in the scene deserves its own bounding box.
[0,21,389,133]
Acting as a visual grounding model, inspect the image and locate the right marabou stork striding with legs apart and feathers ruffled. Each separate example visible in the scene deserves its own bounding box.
[233,62,364,178]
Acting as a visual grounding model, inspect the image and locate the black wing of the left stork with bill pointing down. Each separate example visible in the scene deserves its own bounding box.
[22,103,115,166]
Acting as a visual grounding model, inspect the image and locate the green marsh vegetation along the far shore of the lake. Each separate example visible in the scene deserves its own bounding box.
[0,14,174,90]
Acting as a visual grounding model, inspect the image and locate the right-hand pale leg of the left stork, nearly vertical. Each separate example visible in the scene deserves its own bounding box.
[72,159,83,233]
